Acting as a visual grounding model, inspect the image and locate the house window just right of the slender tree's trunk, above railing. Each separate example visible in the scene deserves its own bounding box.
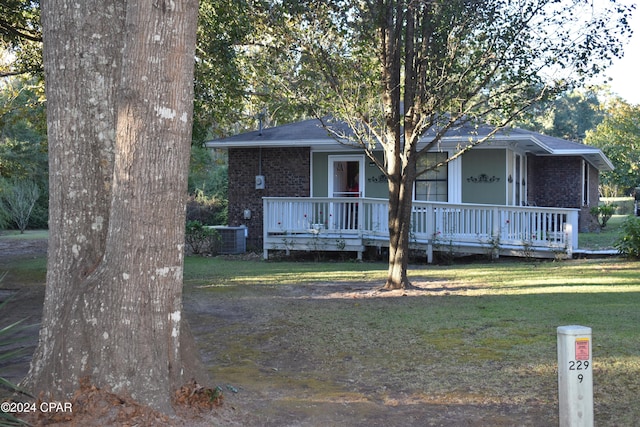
[414,153,449,202]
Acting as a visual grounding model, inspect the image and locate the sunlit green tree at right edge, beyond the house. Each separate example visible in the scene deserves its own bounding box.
[585,99,640,196]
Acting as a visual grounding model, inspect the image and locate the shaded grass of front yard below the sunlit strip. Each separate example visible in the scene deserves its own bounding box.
[186,274,640,425]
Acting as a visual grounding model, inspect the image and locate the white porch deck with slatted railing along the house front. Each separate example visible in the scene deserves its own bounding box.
[263,197,578,262]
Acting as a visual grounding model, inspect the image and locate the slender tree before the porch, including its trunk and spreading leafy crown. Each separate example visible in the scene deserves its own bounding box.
[266,0,630,288]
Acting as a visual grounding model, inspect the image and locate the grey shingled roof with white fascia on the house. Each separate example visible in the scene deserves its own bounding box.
[205,119,613,171]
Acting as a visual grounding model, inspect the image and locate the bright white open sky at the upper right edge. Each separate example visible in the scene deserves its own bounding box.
[605,2,640,105]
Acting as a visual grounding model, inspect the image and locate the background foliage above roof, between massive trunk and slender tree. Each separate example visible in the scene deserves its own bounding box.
[194,0,323,140]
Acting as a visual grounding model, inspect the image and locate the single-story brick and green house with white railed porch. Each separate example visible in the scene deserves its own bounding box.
[206,119,613,257]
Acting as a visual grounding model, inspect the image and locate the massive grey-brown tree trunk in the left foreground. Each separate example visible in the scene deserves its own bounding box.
[25,0,202,411]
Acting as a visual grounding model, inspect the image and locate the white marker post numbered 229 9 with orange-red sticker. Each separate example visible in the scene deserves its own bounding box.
[558,325,593,427]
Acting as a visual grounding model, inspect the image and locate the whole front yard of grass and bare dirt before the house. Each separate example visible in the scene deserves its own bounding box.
[0,226,640,426]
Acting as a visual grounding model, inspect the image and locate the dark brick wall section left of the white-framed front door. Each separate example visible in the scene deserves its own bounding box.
[229,148,311,251]
